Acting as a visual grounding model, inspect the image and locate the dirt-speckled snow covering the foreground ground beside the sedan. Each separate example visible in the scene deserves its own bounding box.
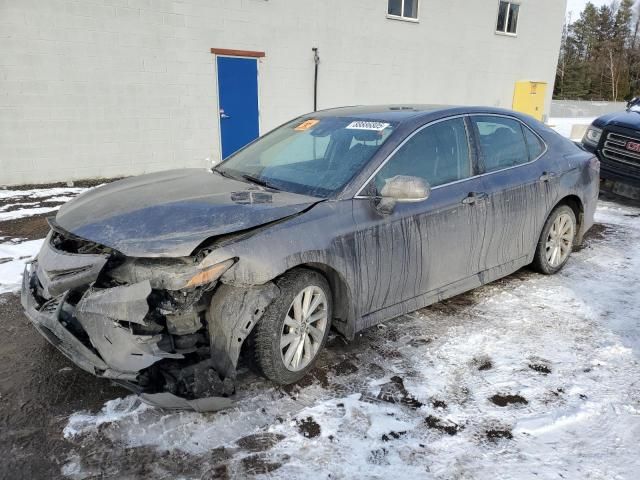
[63,202,640,479]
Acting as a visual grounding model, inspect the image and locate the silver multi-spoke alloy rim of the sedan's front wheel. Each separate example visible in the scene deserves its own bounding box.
[280,286,328,372]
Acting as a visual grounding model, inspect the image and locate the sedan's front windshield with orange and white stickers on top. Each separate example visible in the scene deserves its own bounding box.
[215,117,395,198]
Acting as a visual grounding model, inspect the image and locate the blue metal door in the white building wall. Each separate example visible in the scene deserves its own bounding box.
[217,57,259,158]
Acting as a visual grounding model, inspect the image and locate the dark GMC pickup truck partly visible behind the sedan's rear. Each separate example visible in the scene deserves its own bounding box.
[582,97,640,187]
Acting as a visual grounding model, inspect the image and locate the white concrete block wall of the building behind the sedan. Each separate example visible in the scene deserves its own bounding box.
[0,0,565,185]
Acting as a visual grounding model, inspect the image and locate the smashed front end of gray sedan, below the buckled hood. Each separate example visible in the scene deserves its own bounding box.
[22,222,278,411]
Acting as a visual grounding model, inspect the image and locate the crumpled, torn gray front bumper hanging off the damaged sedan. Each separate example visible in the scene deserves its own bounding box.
[22,262,184,382]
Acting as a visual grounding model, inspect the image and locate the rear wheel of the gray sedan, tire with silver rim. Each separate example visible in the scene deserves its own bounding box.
[533,205,577,275]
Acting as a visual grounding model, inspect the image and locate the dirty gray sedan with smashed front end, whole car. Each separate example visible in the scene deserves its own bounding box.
[22,106,599,410]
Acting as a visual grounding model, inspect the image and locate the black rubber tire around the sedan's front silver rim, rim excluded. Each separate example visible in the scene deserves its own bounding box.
[250,268,332,385]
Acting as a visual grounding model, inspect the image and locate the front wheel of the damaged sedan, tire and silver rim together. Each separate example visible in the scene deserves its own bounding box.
[252,269,332,385]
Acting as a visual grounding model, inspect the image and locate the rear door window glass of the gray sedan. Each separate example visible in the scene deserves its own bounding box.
[471,115,530,172]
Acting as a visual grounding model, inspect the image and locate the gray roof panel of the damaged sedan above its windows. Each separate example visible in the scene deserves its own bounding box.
[304,104,518,123]
